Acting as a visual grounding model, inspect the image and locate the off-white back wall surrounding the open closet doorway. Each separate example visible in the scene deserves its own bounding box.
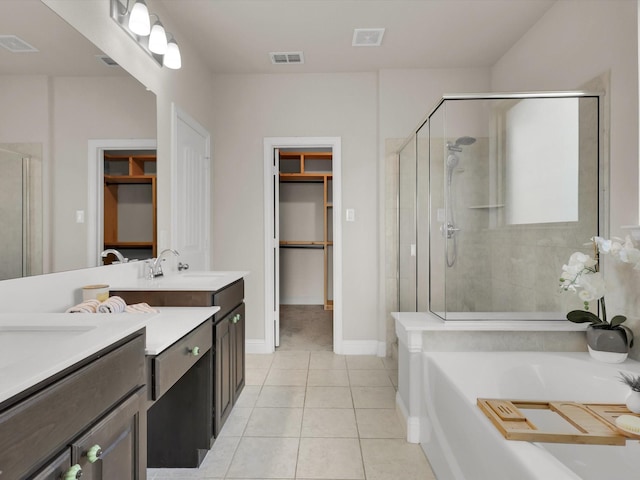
[213,73,379,340]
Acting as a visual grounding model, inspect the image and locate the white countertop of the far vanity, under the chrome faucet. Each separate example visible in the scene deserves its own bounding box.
[109,270,249,292]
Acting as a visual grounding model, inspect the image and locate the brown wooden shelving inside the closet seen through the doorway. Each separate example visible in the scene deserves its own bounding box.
[279,151,333,310]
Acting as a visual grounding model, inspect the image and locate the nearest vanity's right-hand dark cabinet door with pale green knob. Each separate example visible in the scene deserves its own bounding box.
[71,387,147,480]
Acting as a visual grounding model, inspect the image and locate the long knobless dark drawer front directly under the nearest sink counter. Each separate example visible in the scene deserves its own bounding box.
[0,335,145,479]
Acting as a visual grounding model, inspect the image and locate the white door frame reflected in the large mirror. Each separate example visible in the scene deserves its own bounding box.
[85,138,158,267]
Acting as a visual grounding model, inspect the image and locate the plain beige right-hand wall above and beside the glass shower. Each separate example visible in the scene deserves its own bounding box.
[492,0,638,235]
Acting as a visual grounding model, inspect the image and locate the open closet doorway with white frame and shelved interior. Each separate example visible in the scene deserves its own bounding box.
[264,137,342,353]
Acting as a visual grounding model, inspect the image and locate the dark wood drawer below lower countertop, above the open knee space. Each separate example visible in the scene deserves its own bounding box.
[151,321,213,400]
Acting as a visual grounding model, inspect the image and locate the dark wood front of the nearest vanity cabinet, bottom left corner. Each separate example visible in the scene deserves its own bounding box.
[0,330,147,480]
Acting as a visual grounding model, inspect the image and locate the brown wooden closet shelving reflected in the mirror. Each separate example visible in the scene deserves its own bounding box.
[103,152,157,258]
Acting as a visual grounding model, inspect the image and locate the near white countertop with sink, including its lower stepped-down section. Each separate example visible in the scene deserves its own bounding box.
[0,307,219,403]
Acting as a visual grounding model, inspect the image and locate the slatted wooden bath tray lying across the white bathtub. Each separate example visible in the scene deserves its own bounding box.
[478,398,640,445]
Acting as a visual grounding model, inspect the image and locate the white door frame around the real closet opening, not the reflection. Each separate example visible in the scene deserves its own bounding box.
[264,137,343,354]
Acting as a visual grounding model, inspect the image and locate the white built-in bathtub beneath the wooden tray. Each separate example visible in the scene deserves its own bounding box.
[420,352,640,480]
